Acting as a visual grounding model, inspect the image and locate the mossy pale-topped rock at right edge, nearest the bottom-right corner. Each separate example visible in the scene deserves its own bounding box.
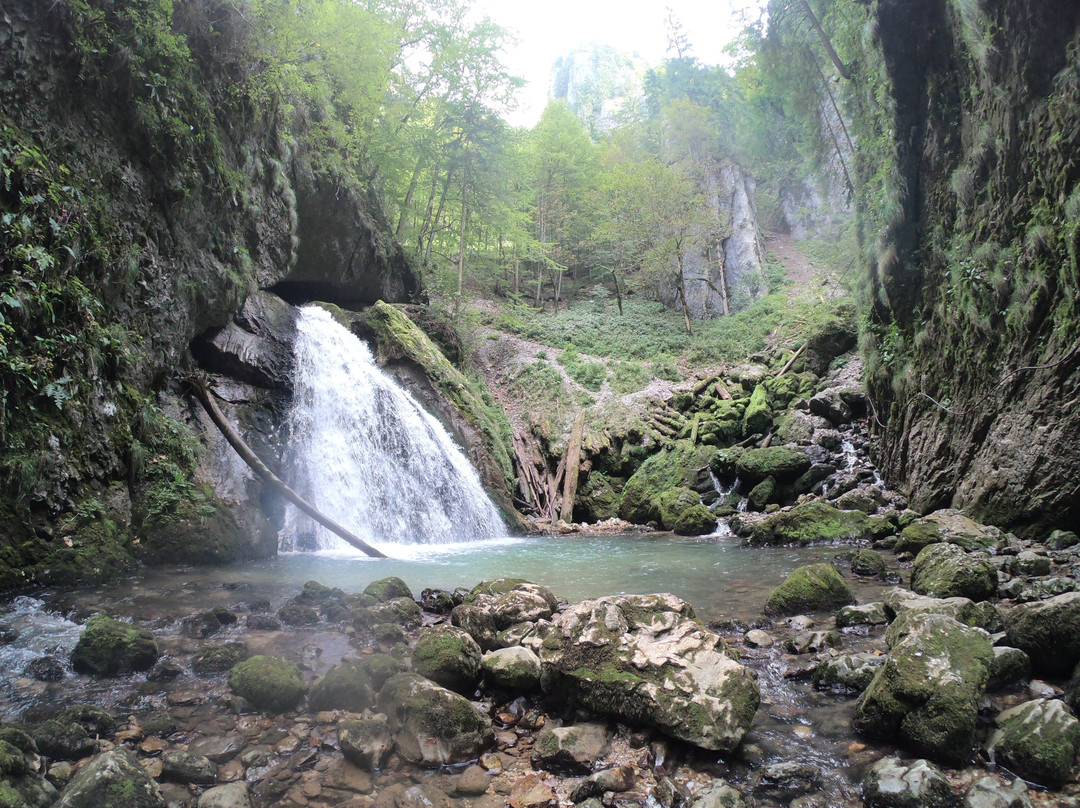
[988,699,1080,787]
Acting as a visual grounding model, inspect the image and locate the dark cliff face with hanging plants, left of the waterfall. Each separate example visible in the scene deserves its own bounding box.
[0,0,422,588]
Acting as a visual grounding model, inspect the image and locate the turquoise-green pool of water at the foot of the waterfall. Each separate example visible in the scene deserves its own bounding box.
[39,534,894,621]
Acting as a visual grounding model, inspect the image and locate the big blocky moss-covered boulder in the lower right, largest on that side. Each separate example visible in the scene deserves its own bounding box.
[852,614,994,766]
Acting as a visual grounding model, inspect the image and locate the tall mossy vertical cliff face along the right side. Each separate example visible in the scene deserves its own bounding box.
[862,0,1080,535]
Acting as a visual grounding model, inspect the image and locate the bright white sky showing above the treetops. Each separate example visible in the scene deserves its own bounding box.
[473,0,756,126]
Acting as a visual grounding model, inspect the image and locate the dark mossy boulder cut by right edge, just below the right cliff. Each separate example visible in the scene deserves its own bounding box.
[1004,592,1080,677]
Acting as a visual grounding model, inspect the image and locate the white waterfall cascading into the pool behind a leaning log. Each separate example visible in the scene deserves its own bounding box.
[280,306,507,551]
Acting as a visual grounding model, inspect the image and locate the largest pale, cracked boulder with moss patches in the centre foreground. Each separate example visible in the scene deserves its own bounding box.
[540,594,760,752]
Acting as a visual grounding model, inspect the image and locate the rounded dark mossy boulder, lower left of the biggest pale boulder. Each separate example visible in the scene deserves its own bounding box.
[378,673,495,766]
